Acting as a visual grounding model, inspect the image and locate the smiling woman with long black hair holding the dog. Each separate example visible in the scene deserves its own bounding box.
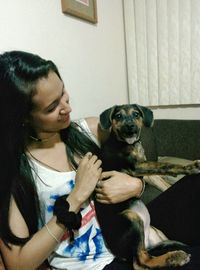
[0,51,143,270]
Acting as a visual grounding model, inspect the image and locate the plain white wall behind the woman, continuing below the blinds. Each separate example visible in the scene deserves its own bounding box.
[0,0,200,119]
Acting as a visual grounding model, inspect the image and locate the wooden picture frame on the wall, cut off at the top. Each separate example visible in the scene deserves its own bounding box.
[61,0,97,23]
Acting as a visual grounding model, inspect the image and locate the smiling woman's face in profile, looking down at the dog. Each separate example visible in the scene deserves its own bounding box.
[30,72,71,135]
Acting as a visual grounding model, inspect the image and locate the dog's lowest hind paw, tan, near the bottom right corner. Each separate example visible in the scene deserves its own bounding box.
[166,250,191,267]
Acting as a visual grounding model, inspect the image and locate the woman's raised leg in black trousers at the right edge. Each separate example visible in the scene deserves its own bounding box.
[147,174,200,245]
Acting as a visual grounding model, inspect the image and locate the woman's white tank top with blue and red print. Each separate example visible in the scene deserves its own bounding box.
[30,119,113,270]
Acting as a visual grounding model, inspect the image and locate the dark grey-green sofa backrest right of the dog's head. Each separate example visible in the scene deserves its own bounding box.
[142,119,200,160]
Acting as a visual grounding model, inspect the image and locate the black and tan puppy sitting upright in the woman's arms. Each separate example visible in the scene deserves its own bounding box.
[95,104,200,270]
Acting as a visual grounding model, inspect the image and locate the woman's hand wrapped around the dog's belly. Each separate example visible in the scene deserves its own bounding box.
[95,171,143,204]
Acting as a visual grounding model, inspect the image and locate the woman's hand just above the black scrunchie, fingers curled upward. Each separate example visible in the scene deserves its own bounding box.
[67,153,102,212]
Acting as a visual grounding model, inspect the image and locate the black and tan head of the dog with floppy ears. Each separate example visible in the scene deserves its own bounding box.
[100,104,153,144]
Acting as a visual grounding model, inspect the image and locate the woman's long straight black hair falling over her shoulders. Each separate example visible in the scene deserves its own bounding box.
[0,51,98,244]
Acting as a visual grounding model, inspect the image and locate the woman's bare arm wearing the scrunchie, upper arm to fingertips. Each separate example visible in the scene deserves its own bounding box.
[0,153,101,270]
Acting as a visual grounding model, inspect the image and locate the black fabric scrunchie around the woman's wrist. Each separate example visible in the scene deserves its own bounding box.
[53,195,82,230]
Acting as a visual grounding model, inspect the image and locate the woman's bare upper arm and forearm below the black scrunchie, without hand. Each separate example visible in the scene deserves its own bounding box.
[1,196,65,270]
